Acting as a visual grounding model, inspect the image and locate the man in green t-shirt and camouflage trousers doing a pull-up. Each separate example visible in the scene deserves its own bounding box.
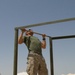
[18,29,48,75]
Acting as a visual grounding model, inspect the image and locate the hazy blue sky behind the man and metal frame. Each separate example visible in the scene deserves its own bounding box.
[0,0,75,75]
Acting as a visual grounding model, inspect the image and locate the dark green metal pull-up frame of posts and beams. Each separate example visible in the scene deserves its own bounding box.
[13,17,75,75]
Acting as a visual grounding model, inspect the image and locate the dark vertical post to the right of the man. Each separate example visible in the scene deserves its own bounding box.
[49,37,54,75]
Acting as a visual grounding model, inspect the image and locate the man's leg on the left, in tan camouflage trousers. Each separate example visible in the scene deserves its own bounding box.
[26,57,38,75]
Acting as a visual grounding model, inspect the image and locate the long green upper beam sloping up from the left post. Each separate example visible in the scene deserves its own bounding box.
[16,17,75,29]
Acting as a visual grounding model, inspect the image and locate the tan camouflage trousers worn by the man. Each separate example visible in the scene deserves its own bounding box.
[26,53,48,75]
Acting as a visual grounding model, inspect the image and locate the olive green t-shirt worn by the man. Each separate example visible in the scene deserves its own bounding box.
[24,36,42,54]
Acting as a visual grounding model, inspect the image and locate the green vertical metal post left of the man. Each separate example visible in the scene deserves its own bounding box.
[13,28,18,75]
